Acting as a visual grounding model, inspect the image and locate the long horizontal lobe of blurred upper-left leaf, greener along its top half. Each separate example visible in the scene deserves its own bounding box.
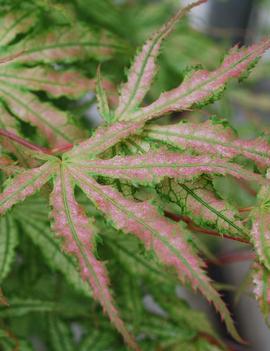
[8,24,124,63]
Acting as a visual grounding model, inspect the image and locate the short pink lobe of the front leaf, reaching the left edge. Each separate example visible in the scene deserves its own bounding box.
[0,161,56,214]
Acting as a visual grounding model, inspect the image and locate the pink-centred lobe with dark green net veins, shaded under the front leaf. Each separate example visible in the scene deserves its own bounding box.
[157,178,247,237]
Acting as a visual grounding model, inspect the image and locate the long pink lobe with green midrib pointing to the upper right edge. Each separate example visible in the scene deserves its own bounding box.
[119,39,270,121]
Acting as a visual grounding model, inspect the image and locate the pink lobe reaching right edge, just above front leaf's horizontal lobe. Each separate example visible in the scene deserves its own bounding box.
[144,121,270,167]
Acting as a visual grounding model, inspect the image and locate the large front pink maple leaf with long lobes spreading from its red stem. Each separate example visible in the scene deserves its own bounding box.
[0,117,265,349]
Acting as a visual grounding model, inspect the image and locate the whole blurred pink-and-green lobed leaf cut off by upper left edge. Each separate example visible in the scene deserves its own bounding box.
[0,11,120,146]
